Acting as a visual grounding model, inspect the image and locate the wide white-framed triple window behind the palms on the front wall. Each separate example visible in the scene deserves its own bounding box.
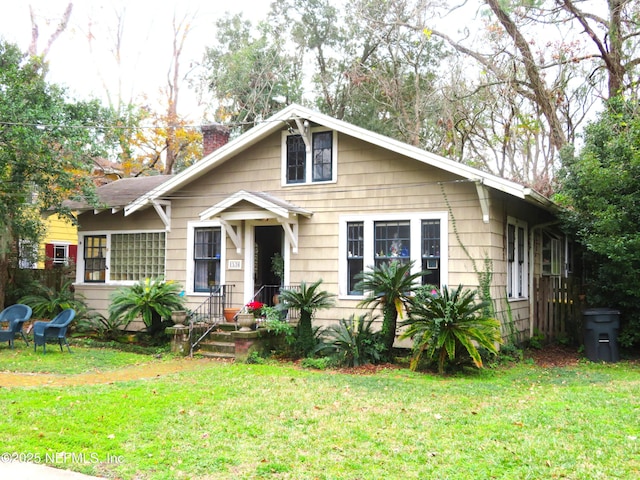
[339,212,447,296]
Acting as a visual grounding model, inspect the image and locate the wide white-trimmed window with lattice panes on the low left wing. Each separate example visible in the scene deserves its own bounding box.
[82,232,166,283]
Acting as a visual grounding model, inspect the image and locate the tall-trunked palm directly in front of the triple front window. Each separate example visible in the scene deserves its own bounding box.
[356,261,423,360]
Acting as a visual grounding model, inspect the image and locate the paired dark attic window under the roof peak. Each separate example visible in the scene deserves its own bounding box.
[283,130,336,185]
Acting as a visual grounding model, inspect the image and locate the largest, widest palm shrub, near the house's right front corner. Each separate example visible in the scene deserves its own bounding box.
[401,285,502,374]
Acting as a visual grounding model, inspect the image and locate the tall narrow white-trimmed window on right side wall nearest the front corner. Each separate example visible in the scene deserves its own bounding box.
[507,218,529,299]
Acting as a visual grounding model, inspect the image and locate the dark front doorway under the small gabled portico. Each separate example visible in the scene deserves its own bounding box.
[254,225,284,305]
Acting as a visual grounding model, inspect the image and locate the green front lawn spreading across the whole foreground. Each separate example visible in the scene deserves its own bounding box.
[0,349,640,480]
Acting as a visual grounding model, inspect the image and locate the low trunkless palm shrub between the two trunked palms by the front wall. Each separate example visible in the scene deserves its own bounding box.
[324,314,383,367]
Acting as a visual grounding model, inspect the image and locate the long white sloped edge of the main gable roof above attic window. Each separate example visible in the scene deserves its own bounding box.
[125,104,556,215]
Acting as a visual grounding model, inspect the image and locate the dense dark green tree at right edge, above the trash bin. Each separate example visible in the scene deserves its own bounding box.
[556,97,640,343]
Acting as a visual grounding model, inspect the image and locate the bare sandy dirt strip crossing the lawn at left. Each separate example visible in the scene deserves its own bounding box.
[0,358,212,388]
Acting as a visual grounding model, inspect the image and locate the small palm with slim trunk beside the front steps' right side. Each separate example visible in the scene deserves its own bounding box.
[278,279,335,357]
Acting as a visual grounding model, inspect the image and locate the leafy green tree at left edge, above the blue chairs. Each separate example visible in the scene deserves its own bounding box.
[0,41,117,305]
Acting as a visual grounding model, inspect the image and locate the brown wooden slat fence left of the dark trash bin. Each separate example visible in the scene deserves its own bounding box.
[533,277,583,343]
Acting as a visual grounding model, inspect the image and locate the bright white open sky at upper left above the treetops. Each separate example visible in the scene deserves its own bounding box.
[0,0,270,121]
